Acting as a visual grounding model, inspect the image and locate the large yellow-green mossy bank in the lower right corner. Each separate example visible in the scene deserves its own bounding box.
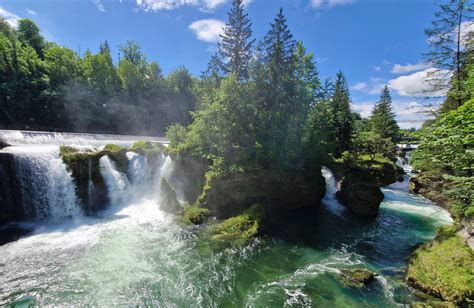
[407,228,474,304]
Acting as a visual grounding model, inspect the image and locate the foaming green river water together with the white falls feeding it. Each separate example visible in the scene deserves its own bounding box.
[0,131,451,307]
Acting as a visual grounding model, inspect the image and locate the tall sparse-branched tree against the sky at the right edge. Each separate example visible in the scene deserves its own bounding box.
[425,0,473,106]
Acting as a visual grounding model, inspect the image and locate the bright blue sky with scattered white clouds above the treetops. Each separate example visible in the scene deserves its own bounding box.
[0,0,444,128]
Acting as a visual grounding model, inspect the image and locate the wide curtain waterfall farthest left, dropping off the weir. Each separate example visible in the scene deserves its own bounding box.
[13,146,82,220]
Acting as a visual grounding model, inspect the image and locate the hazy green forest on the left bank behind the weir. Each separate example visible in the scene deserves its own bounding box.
[0,18,196,135]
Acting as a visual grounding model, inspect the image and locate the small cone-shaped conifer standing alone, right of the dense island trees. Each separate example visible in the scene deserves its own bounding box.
[369,86,400,142]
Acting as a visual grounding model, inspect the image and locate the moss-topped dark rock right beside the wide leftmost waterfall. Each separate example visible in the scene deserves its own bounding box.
[60,146,108,214]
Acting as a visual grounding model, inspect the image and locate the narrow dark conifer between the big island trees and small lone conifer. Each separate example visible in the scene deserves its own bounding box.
[330,71,354,157]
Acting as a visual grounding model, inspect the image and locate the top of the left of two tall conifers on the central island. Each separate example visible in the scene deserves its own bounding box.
[219,0,255,80]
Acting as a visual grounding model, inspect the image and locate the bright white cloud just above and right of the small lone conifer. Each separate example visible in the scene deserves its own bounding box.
[388,68,452,97]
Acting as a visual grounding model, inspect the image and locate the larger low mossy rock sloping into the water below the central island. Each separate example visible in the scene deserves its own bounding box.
[211,204,265,247]
